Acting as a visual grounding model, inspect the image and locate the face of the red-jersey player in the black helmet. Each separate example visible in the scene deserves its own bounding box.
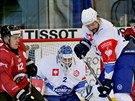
[10,34,20,49]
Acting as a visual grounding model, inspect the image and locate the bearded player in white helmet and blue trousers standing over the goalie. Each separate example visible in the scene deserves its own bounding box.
[74,8,135,101]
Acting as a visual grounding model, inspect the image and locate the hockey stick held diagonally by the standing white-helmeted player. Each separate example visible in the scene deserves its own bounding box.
[81,55,112,101]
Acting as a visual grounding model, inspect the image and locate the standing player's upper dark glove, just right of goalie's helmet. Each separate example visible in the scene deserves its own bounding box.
[74,39,91,59]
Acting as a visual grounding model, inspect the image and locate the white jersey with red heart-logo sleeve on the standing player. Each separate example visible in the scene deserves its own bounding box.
[82,18,128,79]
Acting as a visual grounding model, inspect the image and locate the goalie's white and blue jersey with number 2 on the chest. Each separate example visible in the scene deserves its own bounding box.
[37,55,87,96]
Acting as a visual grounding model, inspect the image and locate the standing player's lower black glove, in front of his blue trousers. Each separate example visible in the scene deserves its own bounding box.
[98,79,113,97]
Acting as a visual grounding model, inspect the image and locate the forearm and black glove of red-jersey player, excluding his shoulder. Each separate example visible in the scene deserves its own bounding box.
[0,65,34,101]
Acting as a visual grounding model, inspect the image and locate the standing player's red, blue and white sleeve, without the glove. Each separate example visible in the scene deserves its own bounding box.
[98,39,117,79]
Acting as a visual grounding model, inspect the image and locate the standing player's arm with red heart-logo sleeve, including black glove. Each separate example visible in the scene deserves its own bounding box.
[98,39,117,97]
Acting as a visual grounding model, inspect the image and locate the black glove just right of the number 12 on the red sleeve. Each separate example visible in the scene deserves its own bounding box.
[26,59,37,76]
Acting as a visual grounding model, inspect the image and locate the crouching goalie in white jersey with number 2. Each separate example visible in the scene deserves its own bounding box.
[37,45,91,101]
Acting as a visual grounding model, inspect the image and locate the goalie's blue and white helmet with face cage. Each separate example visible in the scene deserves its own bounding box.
[57,45,73,69]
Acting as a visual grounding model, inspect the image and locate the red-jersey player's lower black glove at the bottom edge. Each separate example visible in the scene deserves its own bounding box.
[16,89,34,101]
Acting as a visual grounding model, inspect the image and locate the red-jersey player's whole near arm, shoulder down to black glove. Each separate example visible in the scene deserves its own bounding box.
[0,51,35,101]
